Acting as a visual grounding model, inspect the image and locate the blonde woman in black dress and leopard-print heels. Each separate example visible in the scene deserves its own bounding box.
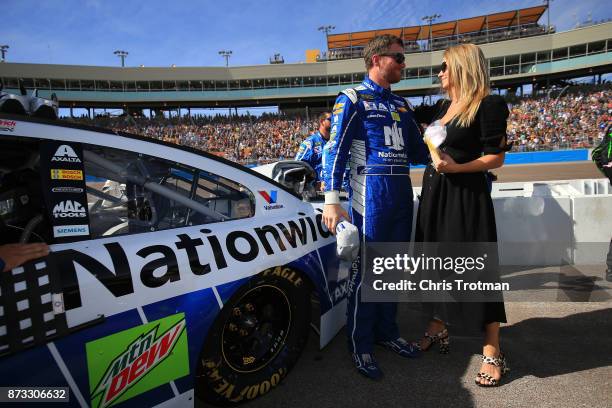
[415,44,510,386]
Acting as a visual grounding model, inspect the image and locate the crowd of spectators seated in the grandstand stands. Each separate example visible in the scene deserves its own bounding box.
[64,86,612,164]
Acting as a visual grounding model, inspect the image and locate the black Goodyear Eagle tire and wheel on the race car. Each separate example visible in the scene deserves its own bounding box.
[195,266,311,406]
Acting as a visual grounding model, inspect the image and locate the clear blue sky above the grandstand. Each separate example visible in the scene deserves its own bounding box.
[0,0,612,67]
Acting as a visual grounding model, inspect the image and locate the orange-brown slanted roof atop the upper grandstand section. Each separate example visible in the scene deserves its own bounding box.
[327,6,547,50]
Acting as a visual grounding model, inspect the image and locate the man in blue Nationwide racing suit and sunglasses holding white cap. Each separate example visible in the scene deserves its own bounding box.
[323,35,428,379]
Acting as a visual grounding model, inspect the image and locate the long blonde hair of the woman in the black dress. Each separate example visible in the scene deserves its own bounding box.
[444,44,491,127]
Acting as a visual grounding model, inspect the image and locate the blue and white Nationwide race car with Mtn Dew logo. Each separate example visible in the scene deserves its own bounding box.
[0,91,351,407]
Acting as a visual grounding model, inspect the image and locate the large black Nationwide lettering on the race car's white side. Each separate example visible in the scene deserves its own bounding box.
[57,214,331,310]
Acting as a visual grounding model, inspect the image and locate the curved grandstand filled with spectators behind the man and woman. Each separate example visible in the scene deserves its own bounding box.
[0,6,612,163]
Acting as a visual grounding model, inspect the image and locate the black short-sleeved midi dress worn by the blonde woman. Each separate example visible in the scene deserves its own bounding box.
[415,95,510,328]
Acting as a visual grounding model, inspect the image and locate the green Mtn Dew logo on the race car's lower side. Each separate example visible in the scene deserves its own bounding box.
[85,313,189,408]
